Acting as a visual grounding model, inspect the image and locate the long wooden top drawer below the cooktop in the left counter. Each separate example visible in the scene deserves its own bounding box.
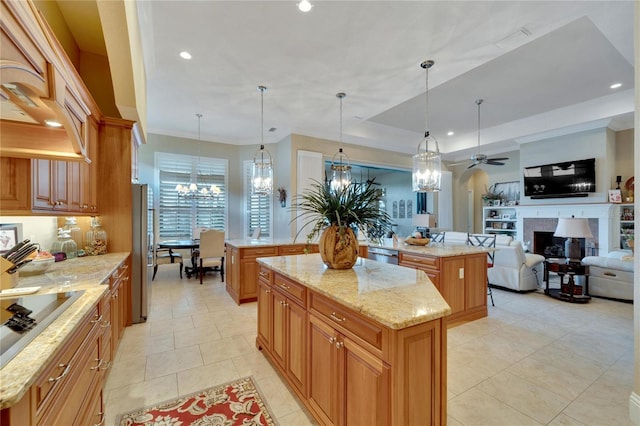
[33,307,98,411]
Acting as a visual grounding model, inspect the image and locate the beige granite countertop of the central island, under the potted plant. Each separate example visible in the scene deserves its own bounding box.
[257,254,451,329]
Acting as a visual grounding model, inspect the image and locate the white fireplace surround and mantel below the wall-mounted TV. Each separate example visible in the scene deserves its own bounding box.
[516,203,620,254]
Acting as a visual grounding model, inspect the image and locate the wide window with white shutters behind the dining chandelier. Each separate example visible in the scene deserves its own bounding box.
[156,152,228,239]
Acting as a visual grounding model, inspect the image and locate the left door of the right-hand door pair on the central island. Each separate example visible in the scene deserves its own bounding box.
[308,315,338,425]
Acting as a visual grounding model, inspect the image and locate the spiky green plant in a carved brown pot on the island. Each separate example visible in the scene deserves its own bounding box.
[291,179,392,269]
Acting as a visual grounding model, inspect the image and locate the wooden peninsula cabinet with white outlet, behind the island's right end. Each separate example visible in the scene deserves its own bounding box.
[398,252,488,325]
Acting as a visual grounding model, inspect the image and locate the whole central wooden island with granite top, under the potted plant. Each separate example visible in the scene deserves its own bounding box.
[256,254,451,425]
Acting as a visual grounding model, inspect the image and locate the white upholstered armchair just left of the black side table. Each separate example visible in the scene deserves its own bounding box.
[487,235,544,291]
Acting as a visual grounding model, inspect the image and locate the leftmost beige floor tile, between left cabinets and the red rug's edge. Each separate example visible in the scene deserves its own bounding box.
[105,374,178,425]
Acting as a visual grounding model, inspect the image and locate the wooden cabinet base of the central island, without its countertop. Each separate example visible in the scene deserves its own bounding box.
[256,265,447,425]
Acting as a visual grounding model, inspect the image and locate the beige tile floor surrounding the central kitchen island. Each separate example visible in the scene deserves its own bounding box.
[104,265,633,426]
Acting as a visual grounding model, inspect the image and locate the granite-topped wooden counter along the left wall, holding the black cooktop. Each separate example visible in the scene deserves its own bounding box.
[0,253,129,426]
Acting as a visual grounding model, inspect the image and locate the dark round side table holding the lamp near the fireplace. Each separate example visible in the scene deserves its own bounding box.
[544,259,591,303]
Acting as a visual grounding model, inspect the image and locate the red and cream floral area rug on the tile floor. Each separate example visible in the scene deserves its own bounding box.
[117,376,277,426]
